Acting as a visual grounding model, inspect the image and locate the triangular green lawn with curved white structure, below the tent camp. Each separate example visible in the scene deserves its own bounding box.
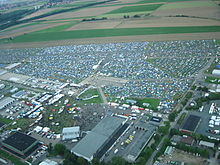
[76,88,103,105]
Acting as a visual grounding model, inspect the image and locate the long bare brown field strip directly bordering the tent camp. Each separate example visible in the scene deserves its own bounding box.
[0,32,220,49]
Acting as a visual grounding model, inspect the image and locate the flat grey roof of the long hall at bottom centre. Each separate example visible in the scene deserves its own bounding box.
[71,116,125,161]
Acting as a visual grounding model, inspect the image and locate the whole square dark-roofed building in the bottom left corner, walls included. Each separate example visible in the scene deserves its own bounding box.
[2,132,38,158]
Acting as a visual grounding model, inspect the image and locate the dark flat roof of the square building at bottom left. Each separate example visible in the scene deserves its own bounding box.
[3,132,37,151]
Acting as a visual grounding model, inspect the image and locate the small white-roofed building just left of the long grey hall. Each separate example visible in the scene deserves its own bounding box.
[62,126,80,140]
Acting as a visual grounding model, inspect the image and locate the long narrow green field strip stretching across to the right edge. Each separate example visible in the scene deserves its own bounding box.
[7,26,220,43]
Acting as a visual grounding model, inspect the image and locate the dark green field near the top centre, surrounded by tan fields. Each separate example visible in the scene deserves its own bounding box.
[106,4,161,14]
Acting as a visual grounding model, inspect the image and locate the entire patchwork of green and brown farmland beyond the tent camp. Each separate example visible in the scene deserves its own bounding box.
[0,0,220,47]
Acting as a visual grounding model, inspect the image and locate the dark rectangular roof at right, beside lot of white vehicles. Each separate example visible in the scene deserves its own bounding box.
[182,115,201,132]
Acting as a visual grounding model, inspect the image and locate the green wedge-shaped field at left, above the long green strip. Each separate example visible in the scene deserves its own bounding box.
[34,22,77,33]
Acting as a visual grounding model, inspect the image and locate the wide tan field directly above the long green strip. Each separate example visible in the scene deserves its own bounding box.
[67,17,220,31]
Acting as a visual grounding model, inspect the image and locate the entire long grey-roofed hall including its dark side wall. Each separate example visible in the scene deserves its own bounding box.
[71,116,128,161]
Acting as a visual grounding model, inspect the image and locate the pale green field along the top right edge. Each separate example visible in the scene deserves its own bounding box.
[160,1,216,9]
